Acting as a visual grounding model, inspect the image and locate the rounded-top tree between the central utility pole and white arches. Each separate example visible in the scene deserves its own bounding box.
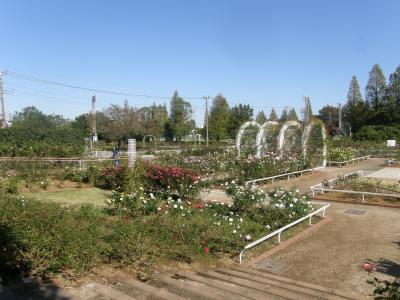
[208,94,229,141]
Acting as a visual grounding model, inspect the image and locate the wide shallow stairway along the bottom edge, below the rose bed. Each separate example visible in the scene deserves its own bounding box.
[66,266,355,300]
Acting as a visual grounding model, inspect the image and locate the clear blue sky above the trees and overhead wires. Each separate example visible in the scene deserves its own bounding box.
[0,0,400,125]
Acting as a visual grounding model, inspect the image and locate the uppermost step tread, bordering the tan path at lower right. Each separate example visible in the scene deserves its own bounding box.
[232,266,354,300]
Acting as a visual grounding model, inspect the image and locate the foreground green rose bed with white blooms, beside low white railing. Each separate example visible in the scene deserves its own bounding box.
[0,172,313,277]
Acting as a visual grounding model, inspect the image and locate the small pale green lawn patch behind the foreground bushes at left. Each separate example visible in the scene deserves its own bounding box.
[23,188,111,206]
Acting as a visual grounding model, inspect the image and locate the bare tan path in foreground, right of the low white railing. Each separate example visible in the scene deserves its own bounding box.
[253,204,400,299]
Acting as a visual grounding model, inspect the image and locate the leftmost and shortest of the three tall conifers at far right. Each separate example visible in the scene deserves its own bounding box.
[343,76,369,132]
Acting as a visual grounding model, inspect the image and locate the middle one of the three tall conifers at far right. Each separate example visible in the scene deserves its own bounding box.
[365,64,386,113]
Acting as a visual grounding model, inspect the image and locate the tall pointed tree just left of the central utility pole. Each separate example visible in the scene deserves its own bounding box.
[169,91,195,141]
